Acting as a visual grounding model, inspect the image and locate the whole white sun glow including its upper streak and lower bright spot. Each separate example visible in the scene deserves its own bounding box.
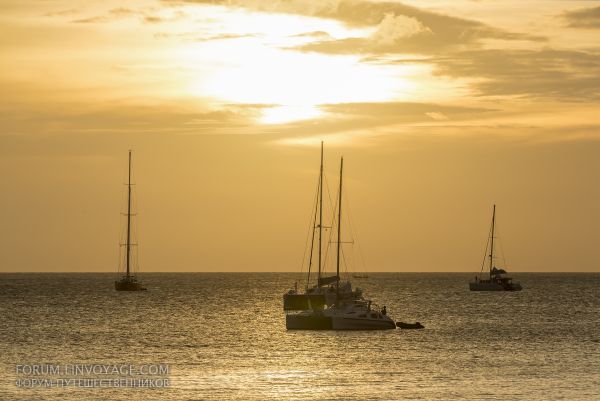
[171,5,415,124]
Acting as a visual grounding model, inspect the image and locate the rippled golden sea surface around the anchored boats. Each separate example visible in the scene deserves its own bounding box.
[0,273,600,400]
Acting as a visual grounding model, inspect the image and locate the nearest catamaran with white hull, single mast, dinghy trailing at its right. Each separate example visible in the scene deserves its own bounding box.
[285,158,396,330]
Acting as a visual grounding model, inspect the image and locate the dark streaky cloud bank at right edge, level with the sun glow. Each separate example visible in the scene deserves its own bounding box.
[429,49,600,102]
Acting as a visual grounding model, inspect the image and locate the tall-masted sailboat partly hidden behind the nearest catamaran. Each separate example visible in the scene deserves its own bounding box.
[283,142,362,311]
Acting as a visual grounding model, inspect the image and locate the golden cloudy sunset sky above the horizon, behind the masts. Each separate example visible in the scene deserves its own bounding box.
[0,0,600,272]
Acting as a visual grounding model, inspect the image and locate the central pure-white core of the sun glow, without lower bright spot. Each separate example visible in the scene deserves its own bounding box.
[192,39,407,106]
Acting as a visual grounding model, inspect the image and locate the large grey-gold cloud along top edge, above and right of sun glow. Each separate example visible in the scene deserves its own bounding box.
[168,0,546,54]
